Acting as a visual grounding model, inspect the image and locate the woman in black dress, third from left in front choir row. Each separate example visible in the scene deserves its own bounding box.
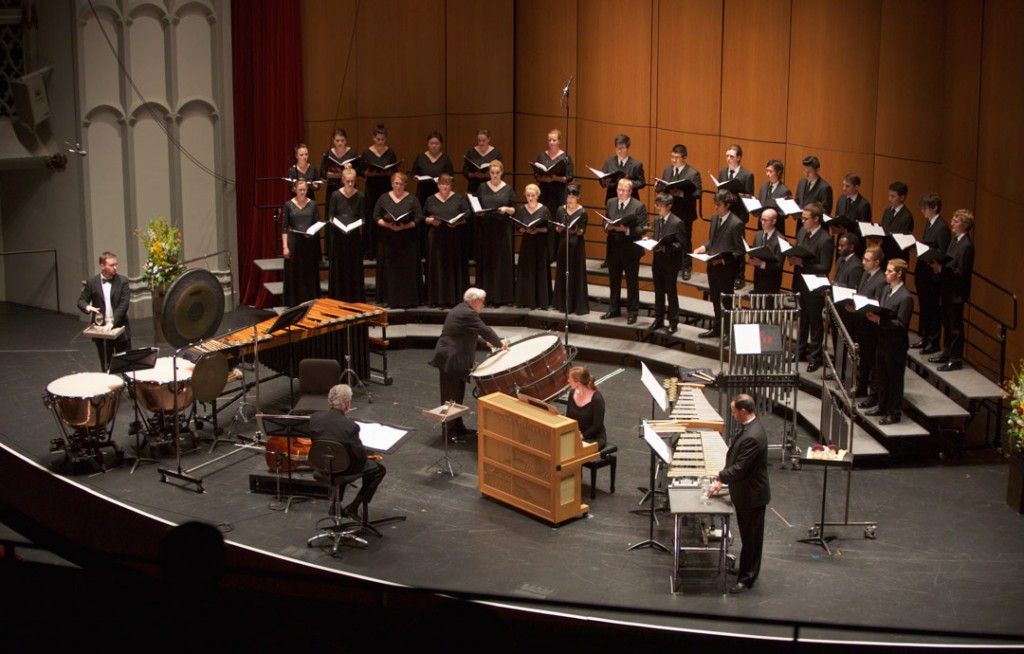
[374,173,423,309]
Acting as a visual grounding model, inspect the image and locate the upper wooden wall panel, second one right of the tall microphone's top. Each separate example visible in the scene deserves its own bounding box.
[653,0,723,135]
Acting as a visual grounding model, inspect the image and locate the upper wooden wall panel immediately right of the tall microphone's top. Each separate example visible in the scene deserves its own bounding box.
[577,0,652,127]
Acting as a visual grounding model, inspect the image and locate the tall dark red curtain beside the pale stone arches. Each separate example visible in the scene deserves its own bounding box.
[231,0,304,308]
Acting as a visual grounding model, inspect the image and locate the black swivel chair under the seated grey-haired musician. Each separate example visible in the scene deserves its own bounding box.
[306,440,368,556]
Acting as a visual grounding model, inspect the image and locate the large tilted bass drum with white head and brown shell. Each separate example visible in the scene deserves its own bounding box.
[469,334,569,401]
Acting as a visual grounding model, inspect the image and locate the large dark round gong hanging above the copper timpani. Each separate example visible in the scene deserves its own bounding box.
[160,268,224,347]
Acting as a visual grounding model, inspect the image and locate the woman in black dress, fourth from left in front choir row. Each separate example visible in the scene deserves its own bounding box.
[423,173,470,307]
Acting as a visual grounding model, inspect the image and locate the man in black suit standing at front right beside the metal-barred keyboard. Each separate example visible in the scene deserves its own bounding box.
[708,394,771,595]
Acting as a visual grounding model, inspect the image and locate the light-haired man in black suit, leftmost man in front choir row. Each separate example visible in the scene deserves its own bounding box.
[601,179,647,324]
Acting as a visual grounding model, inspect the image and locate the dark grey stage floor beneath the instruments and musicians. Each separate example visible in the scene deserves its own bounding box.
[0,304,1024,639]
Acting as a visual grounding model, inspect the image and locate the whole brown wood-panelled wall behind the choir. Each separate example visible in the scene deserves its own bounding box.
[303,0,1024,372]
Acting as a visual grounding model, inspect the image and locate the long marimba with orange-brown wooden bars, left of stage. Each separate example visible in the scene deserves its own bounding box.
[182,298,388,383]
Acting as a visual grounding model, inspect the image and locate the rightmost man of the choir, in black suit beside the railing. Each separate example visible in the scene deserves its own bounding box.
[928,209,974,373]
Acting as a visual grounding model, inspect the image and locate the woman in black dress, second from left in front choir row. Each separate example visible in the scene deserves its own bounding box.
[325,165,367,302]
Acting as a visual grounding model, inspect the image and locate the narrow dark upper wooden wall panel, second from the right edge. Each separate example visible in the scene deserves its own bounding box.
[940,0,982,179]
